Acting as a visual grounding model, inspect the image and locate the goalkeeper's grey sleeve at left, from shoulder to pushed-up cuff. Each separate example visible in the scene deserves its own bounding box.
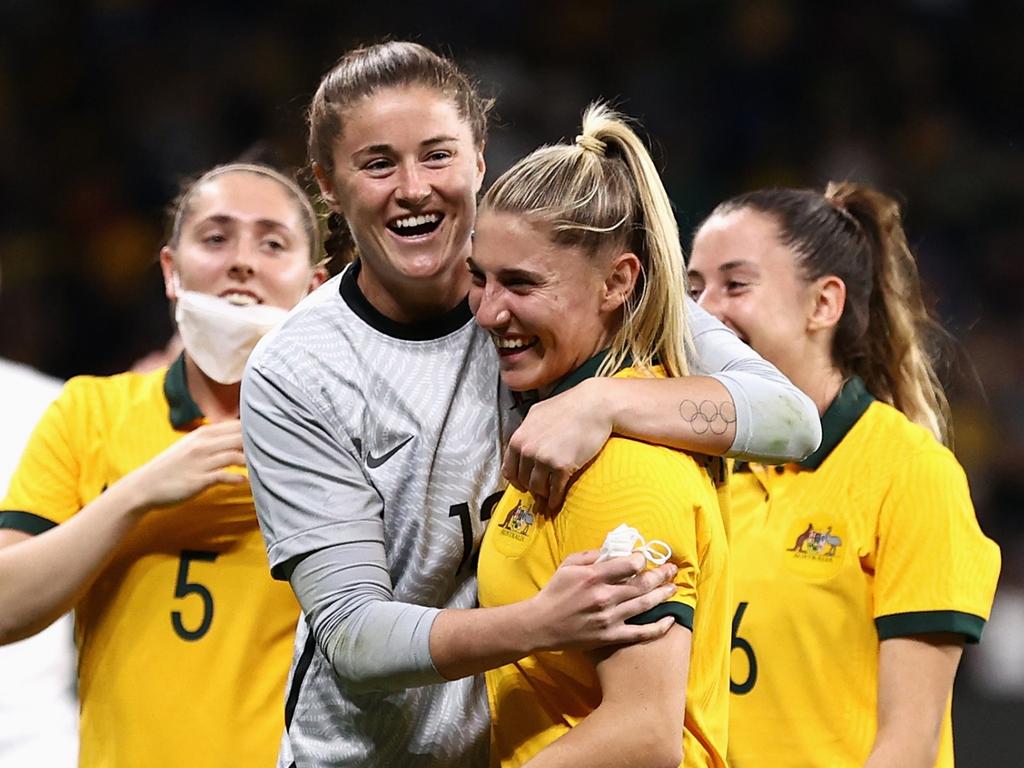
[241,364,442,690]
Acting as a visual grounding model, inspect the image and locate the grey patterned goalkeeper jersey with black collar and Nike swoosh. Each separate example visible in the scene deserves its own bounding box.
[242,263,820,768]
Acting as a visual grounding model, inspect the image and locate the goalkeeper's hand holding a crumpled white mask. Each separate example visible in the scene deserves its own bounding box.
[530,550,677,650]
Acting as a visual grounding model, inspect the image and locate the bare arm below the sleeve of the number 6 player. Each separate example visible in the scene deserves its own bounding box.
[865,634,964,768]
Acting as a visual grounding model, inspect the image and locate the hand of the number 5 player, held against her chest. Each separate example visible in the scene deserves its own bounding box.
[119,419,246,510]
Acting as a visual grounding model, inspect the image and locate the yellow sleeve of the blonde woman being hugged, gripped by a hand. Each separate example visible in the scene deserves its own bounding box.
[556,437,710,630]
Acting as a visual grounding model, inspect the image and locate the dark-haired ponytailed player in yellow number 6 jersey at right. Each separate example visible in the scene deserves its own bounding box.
[690,183,999,768]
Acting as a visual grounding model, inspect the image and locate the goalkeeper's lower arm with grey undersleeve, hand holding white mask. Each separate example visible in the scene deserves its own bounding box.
[289,541,676,692]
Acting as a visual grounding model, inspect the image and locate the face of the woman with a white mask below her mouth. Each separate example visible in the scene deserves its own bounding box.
[160,171,325,309]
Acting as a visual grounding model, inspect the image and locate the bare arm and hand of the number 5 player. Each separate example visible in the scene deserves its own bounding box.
[0,420,245,645]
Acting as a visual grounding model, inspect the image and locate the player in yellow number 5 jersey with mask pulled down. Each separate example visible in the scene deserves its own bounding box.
[0,164,323,768]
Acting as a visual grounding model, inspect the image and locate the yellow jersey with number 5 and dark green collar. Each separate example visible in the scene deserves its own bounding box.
[0,358,299,768]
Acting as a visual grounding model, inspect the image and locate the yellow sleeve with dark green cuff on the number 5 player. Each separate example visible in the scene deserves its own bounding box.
[0,379,88,535]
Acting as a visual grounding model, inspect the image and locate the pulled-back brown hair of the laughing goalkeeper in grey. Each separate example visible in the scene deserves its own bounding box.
[306,41,494,261]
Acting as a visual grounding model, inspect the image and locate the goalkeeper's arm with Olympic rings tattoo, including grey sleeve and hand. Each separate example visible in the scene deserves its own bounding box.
[502,301,821,509]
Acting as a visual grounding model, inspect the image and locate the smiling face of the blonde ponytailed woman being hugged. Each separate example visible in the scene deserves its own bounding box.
[469,212,626,394]
